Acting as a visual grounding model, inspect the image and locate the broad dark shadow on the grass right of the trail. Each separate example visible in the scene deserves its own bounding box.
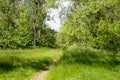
[58,48,120,68]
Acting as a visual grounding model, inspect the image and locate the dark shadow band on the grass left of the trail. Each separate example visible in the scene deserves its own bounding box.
[0,56,52,72]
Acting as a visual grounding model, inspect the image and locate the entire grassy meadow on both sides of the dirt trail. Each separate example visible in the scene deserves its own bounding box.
[0,47,120,80]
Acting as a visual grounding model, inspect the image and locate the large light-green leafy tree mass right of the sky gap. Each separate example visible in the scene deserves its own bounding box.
[58,0,120,53]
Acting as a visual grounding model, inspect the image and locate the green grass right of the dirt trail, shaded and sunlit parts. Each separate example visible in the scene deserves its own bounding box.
[46,48,120,80]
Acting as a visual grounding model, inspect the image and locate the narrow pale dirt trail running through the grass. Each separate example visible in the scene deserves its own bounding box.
[30,62,54,80]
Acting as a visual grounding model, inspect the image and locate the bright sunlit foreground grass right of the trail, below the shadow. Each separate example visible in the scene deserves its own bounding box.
[47,64,120,80]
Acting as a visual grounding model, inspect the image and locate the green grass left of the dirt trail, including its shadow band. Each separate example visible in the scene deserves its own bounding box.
[0,48,62,80]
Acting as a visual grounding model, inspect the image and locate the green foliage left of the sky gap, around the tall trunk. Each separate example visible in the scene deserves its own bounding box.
[0,0,55,49]
